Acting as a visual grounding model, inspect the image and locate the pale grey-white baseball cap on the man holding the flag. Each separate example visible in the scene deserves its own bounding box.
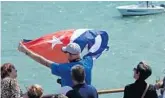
[62,43,81,54]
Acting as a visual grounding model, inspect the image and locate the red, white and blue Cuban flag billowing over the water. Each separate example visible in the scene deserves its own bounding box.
[22,29,109,63]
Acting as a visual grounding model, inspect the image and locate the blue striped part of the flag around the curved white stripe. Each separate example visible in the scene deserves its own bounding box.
[73,30,109,58]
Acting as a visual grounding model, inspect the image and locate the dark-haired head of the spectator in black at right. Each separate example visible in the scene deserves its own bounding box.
[133,61,152,80]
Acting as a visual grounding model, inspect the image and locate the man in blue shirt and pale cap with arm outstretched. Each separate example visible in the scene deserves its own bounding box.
[18,43,93,86]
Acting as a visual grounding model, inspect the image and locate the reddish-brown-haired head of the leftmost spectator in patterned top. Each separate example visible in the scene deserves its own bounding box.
[1,63,17,79]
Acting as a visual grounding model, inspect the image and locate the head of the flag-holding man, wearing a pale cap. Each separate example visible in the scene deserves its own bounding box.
[62,43,81,62]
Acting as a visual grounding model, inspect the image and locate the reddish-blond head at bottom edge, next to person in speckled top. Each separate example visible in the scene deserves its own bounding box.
[22,84,43,98]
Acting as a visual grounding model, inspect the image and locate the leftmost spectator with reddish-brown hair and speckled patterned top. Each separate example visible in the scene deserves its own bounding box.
[1,63,22,98]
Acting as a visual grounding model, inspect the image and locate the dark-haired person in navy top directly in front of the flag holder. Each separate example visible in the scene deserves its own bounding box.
[60,65,98,98]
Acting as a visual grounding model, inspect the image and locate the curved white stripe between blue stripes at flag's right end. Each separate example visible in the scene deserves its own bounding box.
[89,35,102,53]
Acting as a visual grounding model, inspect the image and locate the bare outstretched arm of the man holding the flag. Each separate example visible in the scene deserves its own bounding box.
[18,42,53,68]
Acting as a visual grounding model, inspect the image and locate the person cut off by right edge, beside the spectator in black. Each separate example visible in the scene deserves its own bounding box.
[155,77,165,97]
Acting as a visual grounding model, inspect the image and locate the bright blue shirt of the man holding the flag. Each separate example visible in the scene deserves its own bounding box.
[51,56,93,86]
